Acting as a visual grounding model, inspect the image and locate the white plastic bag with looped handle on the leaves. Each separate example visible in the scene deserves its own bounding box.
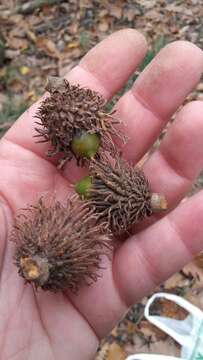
[126,293,203,360]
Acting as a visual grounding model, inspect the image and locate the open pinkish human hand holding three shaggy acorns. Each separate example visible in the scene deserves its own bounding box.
[0,30,203,360]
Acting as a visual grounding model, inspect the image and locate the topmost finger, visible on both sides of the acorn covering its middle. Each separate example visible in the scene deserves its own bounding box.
[6,29,146,157]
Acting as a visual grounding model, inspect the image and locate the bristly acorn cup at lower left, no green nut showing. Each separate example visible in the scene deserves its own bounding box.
[12,197,111,293]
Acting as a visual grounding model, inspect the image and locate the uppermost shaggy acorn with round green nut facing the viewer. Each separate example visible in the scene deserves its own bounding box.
[35,77,124,166]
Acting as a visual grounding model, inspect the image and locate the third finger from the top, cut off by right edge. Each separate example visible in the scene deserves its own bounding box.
[144,101,203,208]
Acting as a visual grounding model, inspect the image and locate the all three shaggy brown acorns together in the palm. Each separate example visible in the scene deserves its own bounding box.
[12,77,167,292]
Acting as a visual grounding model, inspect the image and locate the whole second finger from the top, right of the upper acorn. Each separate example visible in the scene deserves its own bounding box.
[116,41,203,163]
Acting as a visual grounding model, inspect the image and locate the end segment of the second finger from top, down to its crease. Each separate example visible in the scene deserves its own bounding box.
[133,41,203,119]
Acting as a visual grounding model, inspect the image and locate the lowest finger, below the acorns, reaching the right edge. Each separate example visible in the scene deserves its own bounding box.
[113,191,203,305]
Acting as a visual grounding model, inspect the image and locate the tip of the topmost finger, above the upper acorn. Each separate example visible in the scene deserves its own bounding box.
[71,29,147,99]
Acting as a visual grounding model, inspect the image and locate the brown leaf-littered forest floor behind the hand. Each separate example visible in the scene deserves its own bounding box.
[0,0,203,360]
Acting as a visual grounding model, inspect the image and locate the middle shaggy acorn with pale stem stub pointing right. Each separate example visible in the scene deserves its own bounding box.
[75,157,167,235]
